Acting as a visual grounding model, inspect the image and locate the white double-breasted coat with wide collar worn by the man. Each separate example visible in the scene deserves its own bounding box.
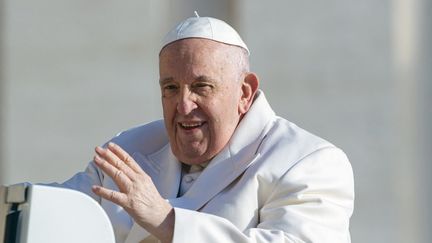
[54,91,354,243]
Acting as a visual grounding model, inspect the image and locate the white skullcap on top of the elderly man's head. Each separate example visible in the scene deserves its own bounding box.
[161,11,250,55]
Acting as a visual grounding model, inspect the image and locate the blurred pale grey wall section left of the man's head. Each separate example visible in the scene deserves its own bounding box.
[2,0,167,183]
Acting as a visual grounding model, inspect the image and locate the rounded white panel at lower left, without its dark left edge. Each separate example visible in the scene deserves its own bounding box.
[18,186,115,243]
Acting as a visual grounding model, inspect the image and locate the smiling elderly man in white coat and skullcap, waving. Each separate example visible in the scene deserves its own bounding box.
[57,16,354,243]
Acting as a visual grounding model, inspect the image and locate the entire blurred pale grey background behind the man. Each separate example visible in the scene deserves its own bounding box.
[0,0,432,243]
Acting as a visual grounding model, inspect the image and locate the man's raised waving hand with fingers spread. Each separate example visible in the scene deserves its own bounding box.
[92,143,174,242]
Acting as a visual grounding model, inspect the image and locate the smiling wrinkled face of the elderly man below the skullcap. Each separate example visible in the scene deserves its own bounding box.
[159,38,246,164]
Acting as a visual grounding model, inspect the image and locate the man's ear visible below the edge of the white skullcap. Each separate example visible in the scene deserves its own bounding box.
[239,73,259,115]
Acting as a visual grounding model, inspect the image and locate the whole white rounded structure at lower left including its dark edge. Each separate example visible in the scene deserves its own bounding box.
[0,184,115,243]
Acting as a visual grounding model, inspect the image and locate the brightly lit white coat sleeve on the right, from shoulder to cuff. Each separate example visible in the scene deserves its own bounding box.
[173,148,354,243]
